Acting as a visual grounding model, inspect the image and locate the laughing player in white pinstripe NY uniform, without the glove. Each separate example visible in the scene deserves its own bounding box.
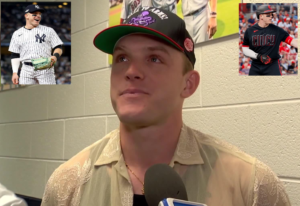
[8,5,63,85]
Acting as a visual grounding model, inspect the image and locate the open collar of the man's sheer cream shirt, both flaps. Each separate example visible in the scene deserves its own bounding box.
[94,124,204,167]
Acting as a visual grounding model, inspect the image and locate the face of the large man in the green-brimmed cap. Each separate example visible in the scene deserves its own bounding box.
[111,34,190,126]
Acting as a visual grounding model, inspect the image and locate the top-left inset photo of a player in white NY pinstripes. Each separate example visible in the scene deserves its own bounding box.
[0,2,71,90]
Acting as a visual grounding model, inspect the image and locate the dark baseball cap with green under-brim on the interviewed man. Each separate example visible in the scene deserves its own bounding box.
[94,7,196,67]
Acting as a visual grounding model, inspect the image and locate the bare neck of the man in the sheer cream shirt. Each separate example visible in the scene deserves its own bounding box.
[120,116,182,173]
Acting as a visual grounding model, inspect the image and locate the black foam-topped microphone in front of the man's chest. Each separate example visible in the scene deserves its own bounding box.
[144,164,206,206]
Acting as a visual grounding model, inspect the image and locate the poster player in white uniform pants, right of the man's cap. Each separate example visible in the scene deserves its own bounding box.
[181,0,217,43]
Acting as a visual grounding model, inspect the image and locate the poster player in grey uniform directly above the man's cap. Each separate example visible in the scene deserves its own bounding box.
[120,0,179,24]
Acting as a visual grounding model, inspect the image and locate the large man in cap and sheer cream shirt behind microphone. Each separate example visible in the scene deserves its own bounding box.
[42,7,290,206]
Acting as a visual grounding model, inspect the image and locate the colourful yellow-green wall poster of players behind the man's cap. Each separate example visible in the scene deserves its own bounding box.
[109,0,241,65]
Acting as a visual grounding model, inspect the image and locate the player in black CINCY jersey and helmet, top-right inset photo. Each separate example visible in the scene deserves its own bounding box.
[243,5,298,75]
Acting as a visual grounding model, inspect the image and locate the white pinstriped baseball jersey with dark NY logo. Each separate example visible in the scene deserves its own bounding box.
[8,25,63,61]
